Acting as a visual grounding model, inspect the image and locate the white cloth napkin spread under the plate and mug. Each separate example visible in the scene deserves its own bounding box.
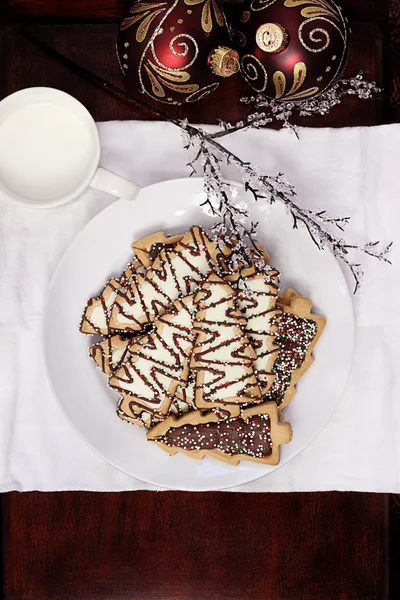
[0,122,400,492]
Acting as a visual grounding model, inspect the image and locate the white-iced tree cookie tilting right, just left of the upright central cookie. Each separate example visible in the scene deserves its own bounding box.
[109,296,194,415]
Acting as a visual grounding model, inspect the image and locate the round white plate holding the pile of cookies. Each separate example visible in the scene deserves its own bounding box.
[43,179,354,490]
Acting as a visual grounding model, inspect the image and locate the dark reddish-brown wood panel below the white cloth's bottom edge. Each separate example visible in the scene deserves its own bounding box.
[3,492,387,600]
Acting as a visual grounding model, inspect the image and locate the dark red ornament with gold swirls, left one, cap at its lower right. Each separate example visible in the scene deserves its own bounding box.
[118,0,239,104]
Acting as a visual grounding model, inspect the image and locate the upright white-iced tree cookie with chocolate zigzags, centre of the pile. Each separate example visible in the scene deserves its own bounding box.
[190,274,261,414]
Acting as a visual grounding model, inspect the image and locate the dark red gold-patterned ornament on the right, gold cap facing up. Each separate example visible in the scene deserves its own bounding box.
[225,0,349,101]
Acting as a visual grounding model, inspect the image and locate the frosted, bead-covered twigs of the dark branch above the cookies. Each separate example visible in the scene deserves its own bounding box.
[181,74,392,292]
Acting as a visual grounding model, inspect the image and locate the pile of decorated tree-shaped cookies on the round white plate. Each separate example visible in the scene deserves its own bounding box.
[80,226,325,465]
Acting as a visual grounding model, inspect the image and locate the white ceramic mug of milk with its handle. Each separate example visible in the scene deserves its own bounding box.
[0,87,139,208]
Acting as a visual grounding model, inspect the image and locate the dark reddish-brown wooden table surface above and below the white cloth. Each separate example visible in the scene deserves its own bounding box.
[0,0,400,600]
